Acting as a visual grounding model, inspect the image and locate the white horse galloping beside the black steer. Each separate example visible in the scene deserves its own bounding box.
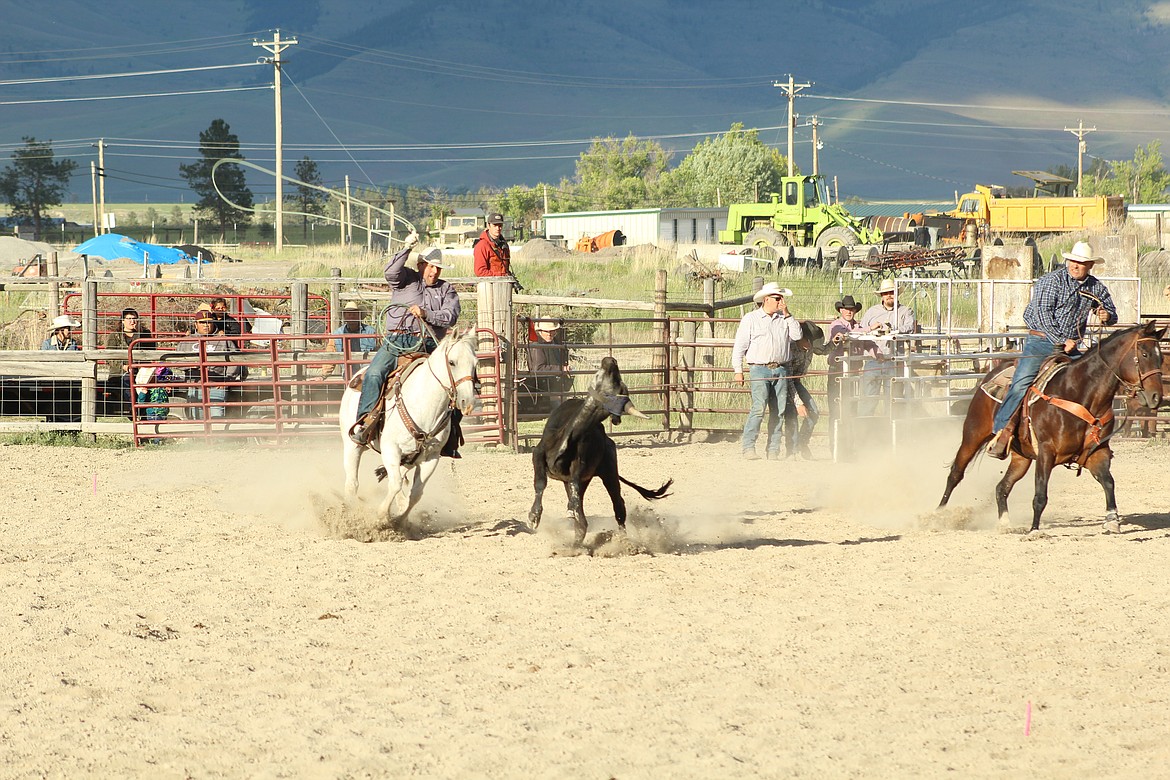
[338,330,479,525]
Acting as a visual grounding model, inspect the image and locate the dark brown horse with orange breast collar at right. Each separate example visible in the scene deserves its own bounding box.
[938,322,1165,532]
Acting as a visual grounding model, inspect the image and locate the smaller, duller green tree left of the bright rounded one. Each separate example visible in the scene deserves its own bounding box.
[572,136,670,209]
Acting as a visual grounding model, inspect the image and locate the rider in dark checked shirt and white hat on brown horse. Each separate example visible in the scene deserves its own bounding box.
[987,241,1117,460]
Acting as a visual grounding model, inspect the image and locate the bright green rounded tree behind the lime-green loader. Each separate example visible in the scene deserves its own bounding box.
[663,122,787,207]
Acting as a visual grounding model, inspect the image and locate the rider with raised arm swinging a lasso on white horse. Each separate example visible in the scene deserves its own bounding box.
[350,230,462,457]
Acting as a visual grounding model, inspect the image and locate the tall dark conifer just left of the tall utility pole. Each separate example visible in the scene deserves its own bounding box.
[179,119,253,241]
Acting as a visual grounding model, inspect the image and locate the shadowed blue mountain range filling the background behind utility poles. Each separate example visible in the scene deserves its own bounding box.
[0,0,1170,202]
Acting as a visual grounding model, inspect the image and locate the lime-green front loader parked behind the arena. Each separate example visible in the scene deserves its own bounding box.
[720,175,885,249]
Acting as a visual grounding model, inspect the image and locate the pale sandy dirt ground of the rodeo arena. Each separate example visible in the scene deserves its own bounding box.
[0,432,1170,779]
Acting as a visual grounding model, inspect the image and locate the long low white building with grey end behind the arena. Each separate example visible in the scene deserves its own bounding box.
[544,208,728,247]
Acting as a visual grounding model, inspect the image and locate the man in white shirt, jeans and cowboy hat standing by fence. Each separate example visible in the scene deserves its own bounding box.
[731,282,801,461]
